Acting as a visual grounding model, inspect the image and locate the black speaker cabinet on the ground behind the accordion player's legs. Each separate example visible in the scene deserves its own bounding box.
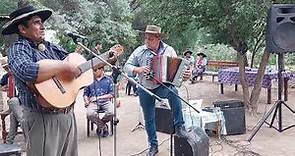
[155,106,173,134]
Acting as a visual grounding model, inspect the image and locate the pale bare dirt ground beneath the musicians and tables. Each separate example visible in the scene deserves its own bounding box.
[1,77,295,156]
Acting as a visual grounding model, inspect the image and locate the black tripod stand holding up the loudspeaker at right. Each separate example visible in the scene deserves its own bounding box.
[248,53,295,142]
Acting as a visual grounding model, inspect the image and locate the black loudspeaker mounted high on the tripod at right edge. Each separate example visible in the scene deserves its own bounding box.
[266,4,295,53]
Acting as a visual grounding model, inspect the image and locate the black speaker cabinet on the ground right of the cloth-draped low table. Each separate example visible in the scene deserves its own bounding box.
[213,100,246,135]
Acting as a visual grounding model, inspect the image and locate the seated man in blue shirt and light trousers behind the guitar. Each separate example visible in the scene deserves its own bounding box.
[83,67,114,137]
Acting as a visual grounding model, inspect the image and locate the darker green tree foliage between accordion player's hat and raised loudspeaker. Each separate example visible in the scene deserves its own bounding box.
[140,0,269,48]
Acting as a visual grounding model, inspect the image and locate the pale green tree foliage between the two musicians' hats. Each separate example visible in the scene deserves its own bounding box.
[44,0,136,57]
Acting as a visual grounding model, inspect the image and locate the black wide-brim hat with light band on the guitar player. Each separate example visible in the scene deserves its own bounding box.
[2,5,52,35]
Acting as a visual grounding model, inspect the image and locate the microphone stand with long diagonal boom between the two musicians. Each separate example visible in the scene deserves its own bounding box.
[75,41,164,156]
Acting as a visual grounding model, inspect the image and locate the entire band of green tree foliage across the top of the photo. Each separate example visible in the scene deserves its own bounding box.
[0,0,295,65]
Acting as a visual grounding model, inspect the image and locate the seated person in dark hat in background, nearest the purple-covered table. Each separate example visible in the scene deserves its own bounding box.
[191,53,207,83]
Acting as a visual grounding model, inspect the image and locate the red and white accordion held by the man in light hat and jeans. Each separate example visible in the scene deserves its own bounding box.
[150,55,190,87]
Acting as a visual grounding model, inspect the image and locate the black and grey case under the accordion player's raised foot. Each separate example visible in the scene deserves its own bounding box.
[174,127,209,156]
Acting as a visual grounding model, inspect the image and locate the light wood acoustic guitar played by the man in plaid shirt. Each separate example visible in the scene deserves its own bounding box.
[34,45,124,109]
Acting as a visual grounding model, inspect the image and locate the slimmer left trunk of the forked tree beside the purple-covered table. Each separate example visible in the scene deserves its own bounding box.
[238,52,251,109]
